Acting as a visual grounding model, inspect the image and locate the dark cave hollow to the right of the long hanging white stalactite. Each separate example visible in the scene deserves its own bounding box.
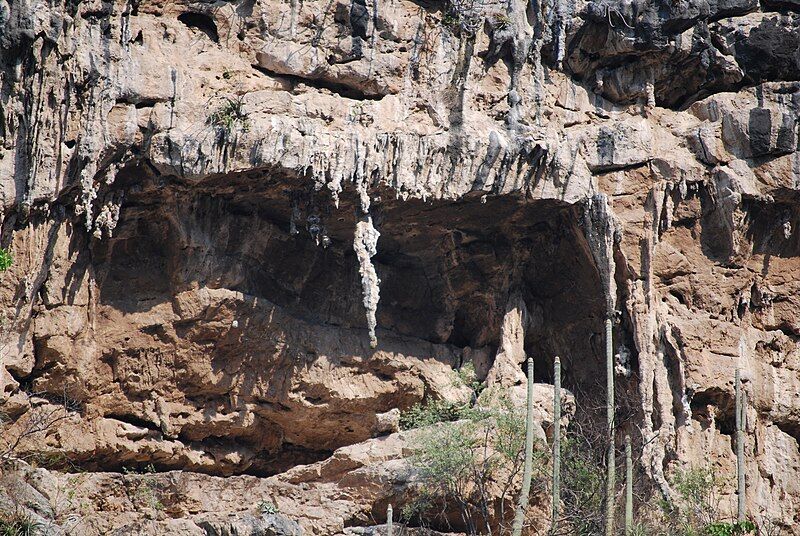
[376,191,605,396]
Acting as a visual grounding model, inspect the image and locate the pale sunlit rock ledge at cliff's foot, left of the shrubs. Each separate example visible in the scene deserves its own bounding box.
[0,385,574,536]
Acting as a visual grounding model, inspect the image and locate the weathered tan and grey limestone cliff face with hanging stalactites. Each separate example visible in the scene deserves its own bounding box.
[0,0,800,534]
